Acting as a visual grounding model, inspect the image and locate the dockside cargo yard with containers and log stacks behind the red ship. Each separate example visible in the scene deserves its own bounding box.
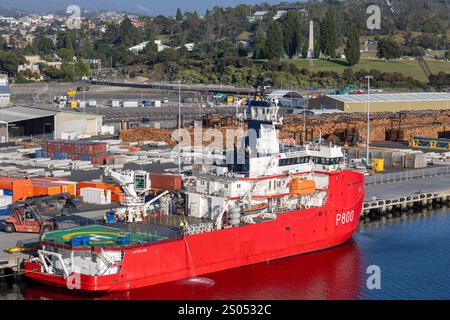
[0,82,450,274]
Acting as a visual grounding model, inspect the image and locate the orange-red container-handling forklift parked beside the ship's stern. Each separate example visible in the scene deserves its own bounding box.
[3,193,78,235]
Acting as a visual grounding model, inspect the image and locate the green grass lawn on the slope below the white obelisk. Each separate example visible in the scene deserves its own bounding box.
[286,59,450,82]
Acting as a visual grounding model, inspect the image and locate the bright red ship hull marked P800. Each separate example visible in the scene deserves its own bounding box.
[24,171,364,292]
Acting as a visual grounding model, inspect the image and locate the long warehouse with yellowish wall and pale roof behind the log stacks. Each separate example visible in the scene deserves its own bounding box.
[309,92,450,112]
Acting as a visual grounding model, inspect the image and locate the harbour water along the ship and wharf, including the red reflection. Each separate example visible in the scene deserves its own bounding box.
[0,208,450,300]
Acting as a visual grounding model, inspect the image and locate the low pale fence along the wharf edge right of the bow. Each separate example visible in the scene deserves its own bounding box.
[365,166,450,185]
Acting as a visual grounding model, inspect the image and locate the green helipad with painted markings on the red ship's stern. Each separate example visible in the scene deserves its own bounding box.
[42,225,165,247]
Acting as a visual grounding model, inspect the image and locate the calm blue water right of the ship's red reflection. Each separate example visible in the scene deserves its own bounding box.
[355,209,450,299]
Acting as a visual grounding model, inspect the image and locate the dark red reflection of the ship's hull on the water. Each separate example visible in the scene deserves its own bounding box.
[22,240,362,300]
